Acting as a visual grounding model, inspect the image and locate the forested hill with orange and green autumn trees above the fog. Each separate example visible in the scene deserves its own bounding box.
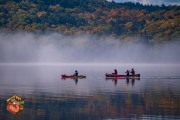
[0,0,180,42]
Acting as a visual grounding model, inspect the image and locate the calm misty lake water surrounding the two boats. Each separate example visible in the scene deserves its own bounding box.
[0,65,180,120]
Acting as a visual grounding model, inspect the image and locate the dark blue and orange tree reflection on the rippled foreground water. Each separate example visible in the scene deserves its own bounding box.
[0,90,180,120]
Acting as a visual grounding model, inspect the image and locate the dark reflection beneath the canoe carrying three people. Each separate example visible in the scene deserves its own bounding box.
[106,77,140,86]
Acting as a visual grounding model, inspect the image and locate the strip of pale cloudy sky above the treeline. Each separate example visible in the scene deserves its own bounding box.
[108,0,180,5]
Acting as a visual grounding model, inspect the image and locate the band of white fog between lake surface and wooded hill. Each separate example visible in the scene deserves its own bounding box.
[0,33,180,64]
